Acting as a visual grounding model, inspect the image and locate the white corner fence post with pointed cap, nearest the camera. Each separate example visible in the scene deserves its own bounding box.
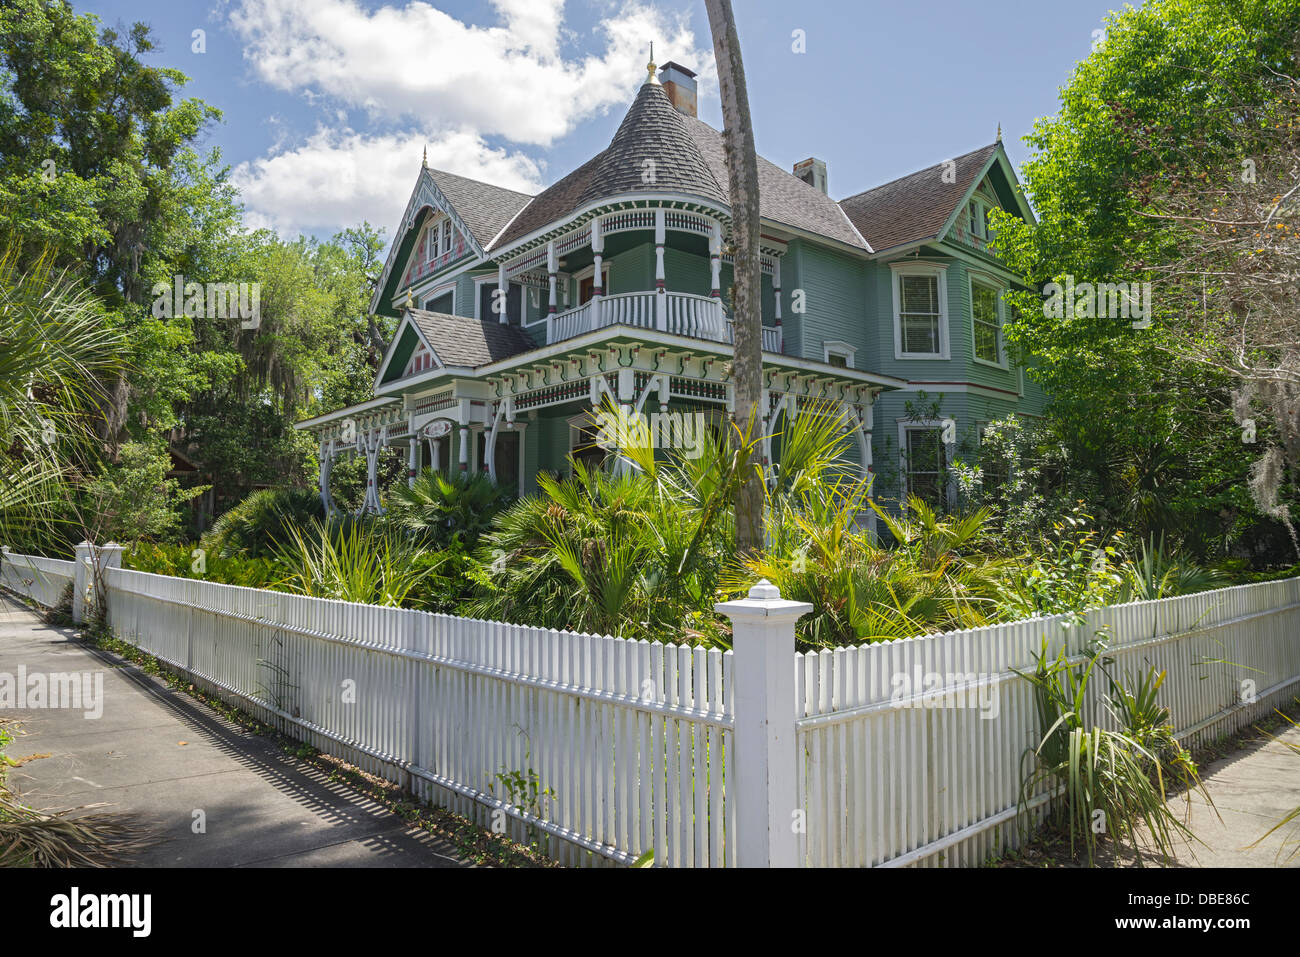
[714,579,813,867]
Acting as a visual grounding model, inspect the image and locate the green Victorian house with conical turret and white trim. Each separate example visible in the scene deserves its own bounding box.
[298,57,1043,511]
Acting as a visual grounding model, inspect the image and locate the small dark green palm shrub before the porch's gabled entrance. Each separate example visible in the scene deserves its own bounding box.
[389,469,511,549]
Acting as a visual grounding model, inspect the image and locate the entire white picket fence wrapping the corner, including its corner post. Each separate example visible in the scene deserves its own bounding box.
[0,546,1300,866]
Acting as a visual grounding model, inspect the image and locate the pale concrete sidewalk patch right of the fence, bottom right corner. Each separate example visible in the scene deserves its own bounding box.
[1171,726,1300,867]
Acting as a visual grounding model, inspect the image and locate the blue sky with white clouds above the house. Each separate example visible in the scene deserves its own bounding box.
[74,0,1119,247]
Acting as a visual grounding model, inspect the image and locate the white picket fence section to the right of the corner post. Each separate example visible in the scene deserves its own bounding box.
[796,579,1300,866]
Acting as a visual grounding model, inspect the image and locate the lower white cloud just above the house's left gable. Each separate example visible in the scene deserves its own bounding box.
[231,127,541,238]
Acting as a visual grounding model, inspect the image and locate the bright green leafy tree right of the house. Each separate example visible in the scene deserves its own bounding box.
[993,0,1300,560]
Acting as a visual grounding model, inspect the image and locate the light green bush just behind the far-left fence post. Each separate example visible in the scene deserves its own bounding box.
[82,442,208,541]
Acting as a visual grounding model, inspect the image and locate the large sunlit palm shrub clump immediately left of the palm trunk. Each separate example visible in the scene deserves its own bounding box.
[468,405,757,642]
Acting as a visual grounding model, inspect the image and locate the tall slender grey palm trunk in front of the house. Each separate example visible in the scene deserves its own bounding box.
[705,0,763,555]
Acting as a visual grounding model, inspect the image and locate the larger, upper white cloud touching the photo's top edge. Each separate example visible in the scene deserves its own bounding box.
[230,0,714,146]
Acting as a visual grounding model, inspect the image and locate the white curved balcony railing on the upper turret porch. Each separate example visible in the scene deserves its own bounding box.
[546,293,781,352]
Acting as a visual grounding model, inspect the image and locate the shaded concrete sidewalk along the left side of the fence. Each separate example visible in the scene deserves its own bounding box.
[0,597,469,867]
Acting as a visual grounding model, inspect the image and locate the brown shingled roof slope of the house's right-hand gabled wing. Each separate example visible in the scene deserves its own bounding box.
[840,143,998,252]
